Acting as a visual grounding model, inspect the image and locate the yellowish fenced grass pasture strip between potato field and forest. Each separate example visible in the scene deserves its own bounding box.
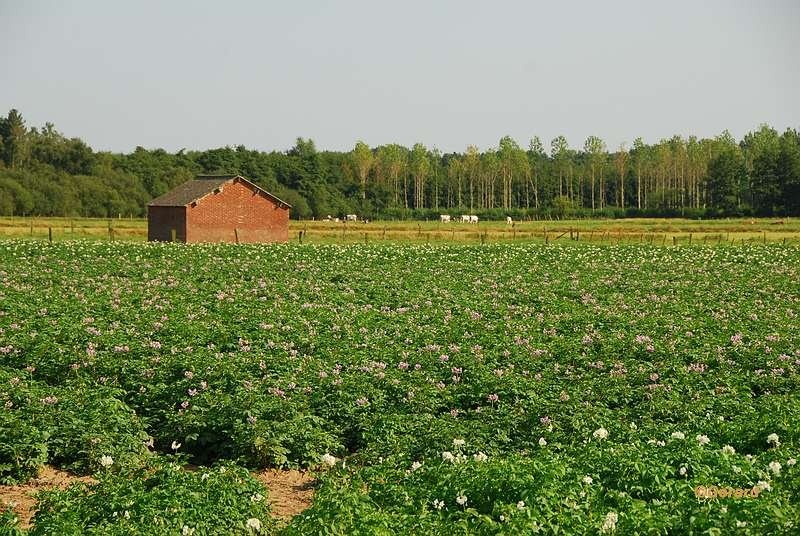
[0,217,800,245]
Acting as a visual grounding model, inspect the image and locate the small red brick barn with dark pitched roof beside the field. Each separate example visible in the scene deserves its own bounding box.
[147,175,291,242]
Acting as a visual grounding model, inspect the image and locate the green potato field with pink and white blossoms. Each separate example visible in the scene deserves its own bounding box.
[0,240,800,536]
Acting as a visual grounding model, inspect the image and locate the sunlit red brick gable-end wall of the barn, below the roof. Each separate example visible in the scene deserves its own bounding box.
[186,180,289,242]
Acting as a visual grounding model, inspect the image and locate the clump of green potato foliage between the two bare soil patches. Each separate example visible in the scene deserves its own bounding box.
[30,462,274,536]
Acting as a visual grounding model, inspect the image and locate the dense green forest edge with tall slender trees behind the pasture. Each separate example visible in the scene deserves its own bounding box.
[0,109,800,220]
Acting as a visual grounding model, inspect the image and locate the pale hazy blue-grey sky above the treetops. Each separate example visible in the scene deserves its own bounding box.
[0,0,800,152]
